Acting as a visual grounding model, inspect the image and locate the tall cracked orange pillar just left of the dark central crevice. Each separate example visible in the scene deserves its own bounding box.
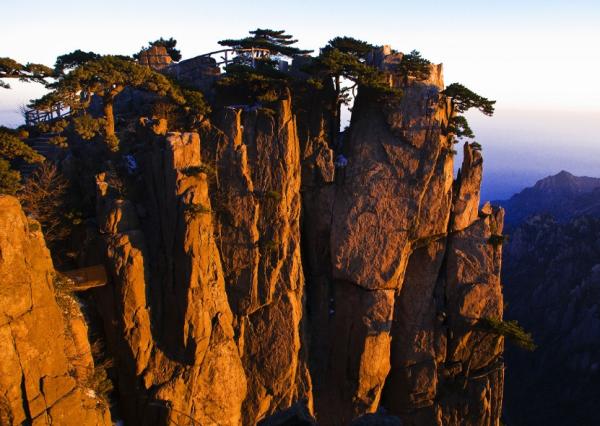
[205,99,311,424]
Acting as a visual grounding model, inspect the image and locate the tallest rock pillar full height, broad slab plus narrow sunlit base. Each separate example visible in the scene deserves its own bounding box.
[304,60,453,424]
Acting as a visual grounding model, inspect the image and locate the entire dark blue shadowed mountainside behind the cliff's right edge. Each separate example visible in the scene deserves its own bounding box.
[499,171,600,426]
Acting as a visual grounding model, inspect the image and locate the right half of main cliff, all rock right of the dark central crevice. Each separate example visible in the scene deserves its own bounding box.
[304,55,503,425]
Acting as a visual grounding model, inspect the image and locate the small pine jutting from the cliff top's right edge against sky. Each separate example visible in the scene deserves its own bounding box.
[442,83,496,142]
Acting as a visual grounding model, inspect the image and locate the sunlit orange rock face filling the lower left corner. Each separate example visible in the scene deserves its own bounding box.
[0,196,112,425]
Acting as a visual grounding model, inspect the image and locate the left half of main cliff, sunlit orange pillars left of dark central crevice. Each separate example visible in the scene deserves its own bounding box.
[97,99,311,424]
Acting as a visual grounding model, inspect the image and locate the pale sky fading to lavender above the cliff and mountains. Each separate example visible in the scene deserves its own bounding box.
[0,0,600,198]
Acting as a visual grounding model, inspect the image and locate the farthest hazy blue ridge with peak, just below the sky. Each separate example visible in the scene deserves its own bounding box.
[494,170,600,226]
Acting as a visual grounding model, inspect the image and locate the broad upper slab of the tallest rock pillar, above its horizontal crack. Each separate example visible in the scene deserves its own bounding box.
[331,63,451,289]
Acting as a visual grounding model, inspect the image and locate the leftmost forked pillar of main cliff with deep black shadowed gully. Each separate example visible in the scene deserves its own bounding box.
[92,134,246,425]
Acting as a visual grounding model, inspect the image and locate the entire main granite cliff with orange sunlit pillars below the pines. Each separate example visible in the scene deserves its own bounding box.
[0,47,504,425]
